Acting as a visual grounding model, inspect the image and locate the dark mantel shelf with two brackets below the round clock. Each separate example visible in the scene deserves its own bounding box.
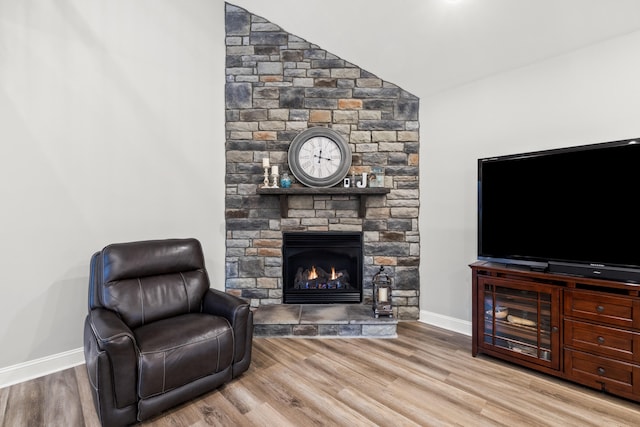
[257,186,391,218]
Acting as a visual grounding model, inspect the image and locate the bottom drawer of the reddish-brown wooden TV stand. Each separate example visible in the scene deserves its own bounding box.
[564,350,640,400]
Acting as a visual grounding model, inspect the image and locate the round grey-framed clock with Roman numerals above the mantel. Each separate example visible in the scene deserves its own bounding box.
[289,127,351,187]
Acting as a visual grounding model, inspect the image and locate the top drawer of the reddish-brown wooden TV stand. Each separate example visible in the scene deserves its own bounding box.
[564,289,640,328]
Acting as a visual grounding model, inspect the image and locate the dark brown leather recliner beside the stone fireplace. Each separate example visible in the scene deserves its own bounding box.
[84,239,253,426]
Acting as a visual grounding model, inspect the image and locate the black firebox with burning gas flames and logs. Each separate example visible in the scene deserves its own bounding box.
[282,232,362,304]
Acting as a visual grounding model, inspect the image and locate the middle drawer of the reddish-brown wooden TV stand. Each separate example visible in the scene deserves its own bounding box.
[564,320,640,363]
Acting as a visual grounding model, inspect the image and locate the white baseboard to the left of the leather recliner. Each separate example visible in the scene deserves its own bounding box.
[0,348,84,388]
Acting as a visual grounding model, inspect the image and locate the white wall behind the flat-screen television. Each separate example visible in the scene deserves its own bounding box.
[420,32,640,333]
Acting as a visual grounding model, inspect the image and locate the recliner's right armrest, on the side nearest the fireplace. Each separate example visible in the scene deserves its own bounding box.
[202,288,253,378]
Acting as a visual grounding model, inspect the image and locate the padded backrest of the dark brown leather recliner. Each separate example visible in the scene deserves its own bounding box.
[89,239,209,328]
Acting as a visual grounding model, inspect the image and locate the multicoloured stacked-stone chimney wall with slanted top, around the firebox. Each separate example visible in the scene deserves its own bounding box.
[225,3,420,319]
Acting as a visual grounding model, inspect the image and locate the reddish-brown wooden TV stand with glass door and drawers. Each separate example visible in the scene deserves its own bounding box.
[470,261,640,402]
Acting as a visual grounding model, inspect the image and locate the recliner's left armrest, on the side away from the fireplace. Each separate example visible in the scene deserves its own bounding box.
[87,308,138,408]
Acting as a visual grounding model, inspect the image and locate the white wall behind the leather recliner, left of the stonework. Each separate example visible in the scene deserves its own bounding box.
[0,0,225,386]
